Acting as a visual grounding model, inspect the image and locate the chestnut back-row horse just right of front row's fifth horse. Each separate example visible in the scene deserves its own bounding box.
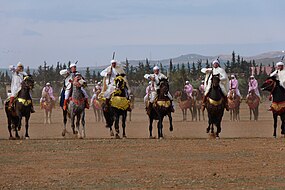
[228,89,240,121]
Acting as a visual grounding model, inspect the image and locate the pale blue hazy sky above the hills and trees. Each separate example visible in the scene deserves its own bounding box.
[0,0,285,68]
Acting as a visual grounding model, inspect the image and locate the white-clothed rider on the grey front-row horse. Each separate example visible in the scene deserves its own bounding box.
[60,63,89,110]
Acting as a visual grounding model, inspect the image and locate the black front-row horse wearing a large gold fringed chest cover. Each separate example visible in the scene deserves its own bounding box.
[103,74,130,139]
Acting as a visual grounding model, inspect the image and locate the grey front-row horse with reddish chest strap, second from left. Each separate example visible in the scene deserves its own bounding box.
[62,76,86,139]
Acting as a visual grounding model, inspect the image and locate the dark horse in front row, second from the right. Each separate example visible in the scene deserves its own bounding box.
[206,74,225,138]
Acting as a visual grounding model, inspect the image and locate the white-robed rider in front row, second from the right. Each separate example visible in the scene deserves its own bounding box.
[201,59,229,111]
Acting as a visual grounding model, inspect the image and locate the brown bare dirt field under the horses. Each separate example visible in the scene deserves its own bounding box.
[0,103,285,189]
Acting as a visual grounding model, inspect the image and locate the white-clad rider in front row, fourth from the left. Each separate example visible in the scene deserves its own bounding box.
[144,66,174,112]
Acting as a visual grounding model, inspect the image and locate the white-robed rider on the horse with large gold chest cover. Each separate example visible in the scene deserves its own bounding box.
[100,59,130,109]
